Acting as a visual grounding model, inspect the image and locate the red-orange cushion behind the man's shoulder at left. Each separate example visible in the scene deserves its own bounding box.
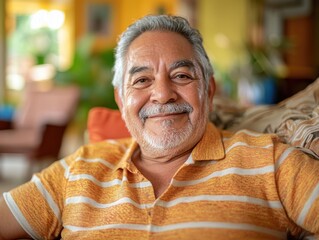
[87,107,131,143]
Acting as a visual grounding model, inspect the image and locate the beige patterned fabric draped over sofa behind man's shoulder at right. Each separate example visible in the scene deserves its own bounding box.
[211,78,319,159]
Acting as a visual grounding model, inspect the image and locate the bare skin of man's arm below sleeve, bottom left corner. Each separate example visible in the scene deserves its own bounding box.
[0,197,30,240]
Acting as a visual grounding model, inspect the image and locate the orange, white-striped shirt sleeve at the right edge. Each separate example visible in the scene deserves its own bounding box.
[275,143,319,237]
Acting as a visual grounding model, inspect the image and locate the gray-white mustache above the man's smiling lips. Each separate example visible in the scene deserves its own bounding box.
[139,103,193,122]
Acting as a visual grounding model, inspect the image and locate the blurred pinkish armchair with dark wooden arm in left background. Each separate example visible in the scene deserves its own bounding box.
[0,86,80,178]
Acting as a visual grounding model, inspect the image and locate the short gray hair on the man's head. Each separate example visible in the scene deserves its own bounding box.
[112,15,213,97]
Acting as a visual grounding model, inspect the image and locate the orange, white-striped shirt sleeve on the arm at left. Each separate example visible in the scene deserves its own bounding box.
[3,151,75,239]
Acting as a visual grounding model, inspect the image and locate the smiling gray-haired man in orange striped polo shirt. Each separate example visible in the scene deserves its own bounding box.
[0,15,319,239]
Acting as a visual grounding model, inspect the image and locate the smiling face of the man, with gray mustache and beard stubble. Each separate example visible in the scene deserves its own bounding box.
[122,31,212,155]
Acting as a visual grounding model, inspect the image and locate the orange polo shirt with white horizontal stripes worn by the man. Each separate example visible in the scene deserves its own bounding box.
[4,123,319,240]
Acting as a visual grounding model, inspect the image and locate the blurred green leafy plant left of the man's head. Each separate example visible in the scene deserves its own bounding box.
[55,36,118,125]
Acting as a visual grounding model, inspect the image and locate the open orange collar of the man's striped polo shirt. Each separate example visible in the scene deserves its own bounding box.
[115,123,225,173]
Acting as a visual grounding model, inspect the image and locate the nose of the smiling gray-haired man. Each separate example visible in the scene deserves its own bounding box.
[150,77,177,104]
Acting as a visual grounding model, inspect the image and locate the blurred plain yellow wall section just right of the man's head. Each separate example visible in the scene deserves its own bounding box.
[198,0,249,70]
